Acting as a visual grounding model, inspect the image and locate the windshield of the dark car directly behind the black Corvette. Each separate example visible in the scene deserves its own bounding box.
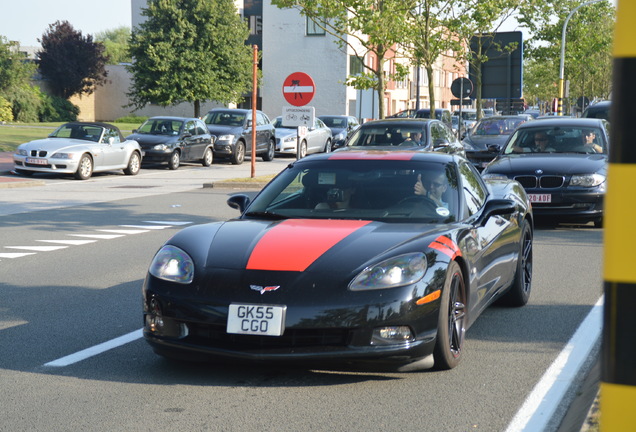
[347,124,427,147]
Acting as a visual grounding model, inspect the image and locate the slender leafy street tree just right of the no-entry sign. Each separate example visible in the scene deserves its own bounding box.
[272,0,415,118]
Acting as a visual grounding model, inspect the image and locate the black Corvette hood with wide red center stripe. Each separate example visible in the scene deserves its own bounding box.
[169,219,447,279]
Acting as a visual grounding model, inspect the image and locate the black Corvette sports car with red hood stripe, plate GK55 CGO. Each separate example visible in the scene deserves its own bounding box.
[143,151,533,370]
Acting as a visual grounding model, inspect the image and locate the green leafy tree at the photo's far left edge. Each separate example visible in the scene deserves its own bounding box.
[0,36,41,122]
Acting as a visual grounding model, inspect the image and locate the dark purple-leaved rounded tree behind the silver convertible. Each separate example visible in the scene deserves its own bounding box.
[37,21,107,99]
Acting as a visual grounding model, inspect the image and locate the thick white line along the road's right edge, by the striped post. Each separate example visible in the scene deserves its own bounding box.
[506,296,604,432]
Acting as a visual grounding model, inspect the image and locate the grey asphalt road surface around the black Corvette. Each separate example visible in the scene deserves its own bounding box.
[0,160,603,432]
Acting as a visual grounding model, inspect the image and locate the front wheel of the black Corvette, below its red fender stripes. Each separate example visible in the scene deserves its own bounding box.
[433,261,466,370]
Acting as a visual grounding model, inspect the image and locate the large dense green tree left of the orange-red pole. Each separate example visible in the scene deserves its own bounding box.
[128,0,252,117]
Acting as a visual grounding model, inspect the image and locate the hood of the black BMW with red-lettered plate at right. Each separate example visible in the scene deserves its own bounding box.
[483,153,607,175]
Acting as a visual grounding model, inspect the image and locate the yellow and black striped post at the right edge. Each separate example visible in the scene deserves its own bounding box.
[601,0,636,432]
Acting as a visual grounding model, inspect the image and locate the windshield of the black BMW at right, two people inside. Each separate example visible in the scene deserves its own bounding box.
[504,125,608,154]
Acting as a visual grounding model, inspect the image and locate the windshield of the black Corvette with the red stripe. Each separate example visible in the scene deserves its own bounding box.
[245,160,458,223]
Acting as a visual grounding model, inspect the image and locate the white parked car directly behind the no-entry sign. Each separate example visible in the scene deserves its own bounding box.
[274,116,332,158]
